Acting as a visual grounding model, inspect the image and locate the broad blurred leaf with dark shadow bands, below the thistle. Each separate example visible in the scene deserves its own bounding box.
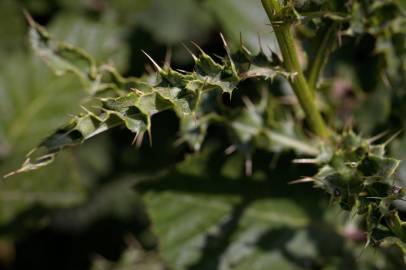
[136,147,399,270]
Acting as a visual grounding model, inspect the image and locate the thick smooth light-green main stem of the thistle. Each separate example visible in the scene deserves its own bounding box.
[261,0,329,137]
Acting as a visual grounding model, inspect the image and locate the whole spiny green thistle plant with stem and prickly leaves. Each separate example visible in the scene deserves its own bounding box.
[4,0,406,266]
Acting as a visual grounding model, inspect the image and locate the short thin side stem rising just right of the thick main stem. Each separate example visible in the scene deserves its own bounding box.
[308,23,337,90]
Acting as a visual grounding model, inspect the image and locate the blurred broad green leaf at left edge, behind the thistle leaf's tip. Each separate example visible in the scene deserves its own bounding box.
[0,54,87,226]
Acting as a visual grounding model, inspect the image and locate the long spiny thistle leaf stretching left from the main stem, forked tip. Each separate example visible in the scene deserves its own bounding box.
[7,17,292,174]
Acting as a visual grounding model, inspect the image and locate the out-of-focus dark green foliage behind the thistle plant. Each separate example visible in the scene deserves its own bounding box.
[0,0,406,270]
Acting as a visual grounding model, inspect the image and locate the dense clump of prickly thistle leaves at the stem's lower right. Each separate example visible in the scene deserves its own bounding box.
[313,131,406,250]
